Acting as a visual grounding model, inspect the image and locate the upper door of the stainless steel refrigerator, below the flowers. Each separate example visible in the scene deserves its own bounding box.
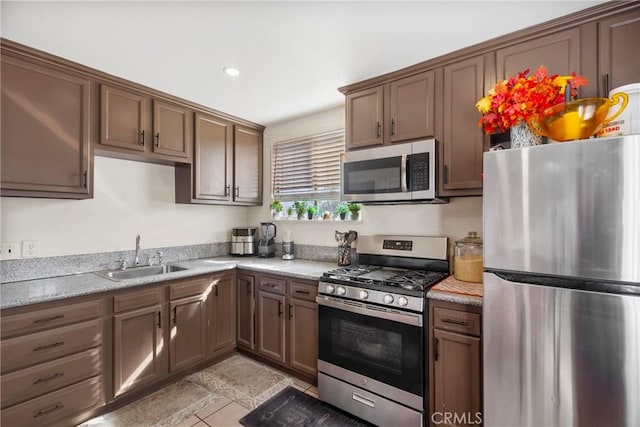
[483,134,640,283]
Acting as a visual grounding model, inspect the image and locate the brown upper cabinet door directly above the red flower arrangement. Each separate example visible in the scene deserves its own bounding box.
[498,28,580,80]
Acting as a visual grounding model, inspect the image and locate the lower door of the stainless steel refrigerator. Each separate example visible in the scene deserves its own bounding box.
[483,273,640,427]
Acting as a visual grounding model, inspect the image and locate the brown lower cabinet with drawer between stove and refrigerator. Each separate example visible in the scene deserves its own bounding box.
[428,300,482,426]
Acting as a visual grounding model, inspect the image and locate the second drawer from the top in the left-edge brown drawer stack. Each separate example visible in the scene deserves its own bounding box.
[0,319,103,373]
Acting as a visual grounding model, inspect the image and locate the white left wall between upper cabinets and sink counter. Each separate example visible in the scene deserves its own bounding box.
[0,156,247,257]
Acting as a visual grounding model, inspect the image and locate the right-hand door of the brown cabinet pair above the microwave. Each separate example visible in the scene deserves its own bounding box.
[389,71,435,142]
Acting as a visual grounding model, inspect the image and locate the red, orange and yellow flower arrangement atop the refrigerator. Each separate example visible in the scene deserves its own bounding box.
[476,66,587,133]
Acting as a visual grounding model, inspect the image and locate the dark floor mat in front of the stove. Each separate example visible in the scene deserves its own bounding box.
[240,387,371,427]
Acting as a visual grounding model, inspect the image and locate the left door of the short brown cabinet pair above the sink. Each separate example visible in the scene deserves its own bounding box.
[100,85,151,151]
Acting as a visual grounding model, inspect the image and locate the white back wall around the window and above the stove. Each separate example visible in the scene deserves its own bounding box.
[248,106,482,246]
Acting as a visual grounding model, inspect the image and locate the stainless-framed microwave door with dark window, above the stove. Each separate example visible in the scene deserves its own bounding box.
[340,144,411,202]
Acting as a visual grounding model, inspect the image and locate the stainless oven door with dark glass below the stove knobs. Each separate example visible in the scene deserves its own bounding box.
[317,296,424,407]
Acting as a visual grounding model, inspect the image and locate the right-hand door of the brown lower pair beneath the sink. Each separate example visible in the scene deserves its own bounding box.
[169,295,207,371]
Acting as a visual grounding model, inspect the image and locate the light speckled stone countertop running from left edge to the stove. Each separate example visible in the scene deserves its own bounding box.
[0,257,336,309]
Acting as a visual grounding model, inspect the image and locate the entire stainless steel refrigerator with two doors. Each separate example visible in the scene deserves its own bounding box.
[483,135,640,427]
